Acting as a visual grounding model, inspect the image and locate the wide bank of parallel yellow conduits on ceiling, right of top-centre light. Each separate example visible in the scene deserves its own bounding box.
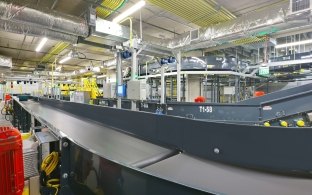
[149,0,236,27]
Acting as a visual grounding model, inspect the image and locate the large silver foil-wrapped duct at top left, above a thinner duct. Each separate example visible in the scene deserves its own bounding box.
[0,1,89,37]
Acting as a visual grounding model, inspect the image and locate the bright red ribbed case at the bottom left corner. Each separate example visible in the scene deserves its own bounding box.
[0,127,24,195]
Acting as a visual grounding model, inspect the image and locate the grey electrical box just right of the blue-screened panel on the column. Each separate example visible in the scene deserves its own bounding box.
[127,80,147,100]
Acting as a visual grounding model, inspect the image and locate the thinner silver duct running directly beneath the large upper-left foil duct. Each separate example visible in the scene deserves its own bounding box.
[0,20,78,43]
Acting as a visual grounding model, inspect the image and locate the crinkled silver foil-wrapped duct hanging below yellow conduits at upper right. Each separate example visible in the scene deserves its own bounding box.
[162,8,286,50]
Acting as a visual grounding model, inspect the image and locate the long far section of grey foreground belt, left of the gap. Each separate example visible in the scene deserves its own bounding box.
[20,101,173,166]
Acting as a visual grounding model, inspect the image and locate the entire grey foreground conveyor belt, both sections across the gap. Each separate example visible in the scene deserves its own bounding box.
[15,99,312,195]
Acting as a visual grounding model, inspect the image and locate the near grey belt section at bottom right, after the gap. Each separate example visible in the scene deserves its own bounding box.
[144,154,312,195]
